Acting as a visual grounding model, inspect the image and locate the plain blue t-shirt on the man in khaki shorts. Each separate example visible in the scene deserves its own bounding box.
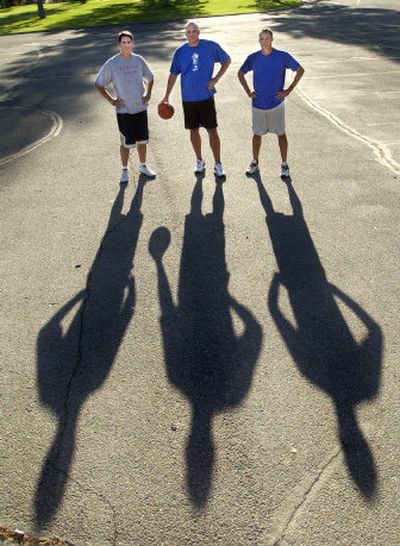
[240,49,300,110]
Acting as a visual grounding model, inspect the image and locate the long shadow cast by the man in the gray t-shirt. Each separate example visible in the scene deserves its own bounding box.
[35,176,145,528]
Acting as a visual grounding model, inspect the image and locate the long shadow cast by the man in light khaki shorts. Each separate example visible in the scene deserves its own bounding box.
[254,175,383,499]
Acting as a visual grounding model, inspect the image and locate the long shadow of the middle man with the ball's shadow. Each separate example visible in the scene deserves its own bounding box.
[149,175,262,509]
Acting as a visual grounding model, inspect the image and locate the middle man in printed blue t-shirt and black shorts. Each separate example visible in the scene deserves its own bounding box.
[161,21,231,177]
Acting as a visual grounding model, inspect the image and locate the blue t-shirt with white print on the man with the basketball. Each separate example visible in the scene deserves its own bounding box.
[170,40,229,102]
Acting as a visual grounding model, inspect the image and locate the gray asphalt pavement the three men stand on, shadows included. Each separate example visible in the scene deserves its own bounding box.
[0,0,400,546]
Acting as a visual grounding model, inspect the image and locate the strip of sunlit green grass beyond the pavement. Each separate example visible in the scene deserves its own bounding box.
[0,0,300,34]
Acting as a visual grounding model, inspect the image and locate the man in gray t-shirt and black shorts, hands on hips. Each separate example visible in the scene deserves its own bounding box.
[95,30,155,183]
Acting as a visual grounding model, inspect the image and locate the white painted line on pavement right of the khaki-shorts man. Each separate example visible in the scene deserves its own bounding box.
[296,89,400,175]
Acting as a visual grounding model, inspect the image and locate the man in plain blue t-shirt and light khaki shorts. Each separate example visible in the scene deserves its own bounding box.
[238,28,304,178]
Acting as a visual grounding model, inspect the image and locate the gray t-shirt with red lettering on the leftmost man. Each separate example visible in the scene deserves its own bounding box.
[96,53,154,114]
